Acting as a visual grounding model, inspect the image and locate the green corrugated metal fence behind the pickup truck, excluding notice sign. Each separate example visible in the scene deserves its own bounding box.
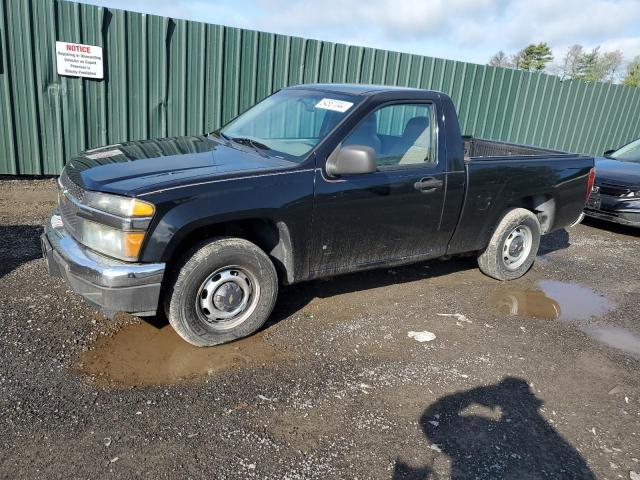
[0,0,640,175]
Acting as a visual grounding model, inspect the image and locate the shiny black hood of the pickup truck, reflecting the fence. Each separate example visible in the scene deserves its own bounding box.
[65,136,294,195]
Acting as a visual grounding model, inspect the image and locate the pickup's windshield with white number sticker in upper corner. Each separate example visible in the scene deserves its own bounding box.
[217,89,359,160]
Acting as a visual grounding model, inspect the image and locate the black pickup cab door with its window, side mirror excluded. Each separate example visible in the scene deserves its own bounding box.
[311,102,451,276]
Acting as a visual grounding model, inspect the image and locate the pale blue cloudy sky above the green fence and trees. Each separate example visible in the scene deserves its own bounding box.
[82,0,640,64]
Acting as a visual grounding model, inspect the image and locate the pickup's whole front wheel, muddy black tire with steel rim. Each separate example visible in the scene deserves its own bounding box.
[164,238,278,347]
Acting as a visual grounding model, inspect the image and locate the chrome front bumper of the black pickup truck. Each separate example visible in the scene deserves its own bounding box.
[41,211,165,316]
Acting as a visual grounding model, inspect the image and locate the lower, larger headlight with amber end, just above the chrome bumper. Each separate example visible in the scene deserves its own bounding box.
[81,219,145,261]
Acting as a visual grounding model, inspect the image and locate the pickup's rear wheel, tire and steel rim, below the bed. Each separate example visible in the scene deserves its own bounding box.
[478,208,540,280]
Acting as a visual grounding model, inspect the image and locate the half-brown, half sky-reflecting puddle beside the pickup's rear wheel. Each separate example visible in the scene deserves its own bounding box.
[491,280,612,321]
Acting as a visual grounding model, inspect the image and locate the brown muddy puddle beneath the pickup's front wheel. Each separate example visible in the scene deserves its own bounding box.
[74,322,282,386]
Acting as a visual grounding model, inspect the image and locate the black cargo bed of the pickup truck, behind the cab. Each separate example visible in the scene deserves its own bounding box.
[448,141,593,254]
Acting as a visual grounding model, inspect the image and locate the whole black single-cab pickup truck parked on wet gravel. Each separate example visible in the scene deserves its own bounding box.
[42,84,595,346]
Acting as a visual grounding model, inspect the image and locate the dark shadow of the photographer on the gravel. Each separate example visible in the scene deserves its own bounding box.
[393,377,595,480]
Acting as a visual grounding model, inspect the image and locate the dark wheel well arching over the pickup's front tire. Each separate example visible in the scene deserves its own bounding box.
[167,218,295,283]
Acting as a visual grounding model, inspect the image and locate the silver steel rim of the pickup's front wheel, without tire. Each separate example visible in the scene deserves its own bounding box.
[196,266,260,330]
